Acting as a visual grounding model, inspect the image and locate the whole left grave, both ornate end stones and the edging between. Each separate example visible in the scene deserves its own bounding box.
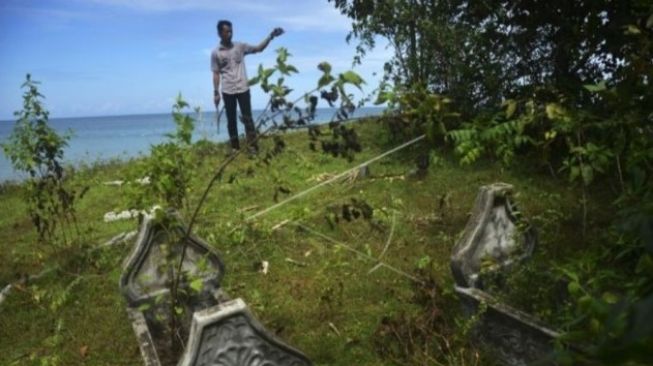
[120,212,311,366]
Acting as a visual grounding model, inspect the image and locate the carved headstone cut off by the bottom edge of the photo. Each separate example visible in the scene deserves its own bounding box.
[179,299,312,366]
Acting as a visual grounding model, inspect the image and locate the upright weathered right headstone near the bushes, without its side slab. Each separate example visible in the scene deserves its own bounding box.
[451,183,536,288]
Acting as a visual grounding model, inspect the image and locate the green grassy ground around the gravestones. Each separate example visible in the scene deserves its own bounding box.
[0,118,600,365]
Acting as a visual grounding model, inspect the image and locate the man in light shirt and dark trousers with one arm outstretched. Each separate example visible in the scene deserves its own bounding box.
[211,20,283,153]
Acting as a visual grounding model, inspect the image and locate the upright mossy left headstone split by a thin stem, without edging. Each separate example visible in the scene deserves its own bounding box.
[120,213,224,306]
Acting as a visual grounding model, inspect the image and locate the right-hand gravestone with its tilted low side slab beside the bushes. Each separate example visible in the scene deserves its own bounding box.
[451,183,560,365]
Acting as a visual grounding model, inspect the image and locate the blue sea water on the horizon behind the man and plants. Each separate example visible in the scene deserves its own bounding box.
[0,107,382,181]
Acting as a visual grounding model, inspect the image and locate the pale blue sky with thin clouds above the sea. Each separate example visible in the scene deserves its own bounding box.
[0,0,390,120]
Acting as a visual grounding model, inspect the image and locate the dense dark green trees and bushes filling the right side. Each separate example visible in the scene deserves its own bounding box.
[332,0,653,363]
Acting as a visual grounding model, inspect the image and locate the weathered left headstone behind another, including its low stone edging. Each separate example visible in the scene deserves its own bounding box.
[120,210,224,366]
